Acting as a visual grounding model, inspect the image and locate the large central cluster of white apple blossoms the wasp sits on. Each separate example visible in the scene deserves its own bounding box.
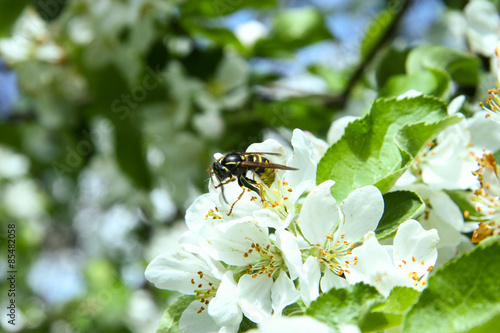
[145,127,439,332]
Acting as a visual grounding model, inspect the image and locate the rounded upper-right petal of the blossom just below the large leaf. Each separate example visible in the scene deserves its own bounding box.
[335,185,384,240]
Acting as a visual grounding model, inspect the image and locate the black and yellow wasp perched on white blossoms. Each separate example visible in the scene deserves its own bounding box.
[207,152,298,215]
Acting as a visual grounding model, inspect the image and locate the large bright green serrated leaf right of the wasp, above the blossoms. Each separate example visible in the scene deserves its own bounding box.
[316,96,458,201]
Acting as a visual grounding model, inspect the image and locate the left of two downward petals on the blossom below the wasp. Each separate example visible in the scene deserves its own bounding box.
[238,274,273,323]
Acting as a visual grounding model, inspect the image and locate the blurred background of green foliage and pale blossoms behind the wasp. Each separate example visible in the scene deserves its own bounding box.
[0,0,494,332]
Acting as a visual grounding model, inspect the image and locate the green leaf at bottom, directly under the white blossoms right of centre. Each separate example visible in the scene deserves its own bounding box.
[306,283,384,328]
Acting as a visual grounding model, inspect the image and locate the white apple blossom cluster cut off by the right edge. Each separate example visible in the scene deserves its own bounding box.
[388,92,500,266]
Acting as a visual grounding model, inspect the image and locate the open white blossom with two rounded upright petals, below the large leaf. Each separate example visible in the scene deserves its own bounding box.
[298,181,384,305]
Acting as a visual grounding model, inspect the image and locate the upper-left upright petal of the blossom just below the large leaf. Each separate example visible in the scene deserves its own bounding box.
[299,180,339,244]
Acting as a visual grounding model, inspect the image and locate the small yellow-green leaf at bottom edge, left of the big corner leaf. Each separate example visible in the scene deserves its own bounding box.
[359,287,420,332]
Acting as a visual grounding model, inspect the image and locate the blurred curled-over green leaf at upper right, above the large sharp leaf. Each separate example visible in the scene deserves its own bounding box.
[406,45,480,86]
